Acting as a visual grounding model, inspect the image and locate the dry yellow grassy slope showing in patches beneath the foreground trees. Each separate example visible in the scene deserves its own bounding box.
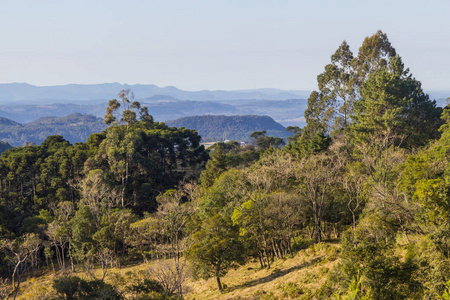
[19,243,339,300]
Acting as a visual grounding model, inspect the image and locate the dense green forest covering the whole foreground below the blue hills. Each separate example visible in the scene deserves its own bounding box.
[0,31,450,299]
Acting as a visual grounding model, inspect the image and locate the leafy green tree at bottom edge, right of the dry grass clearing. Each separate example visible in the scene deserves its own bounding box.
[338,214,421,299]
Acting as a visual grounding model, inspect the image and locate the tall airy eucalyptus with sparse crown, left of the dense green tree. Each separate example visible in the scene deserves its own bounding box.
[303,31,396,137]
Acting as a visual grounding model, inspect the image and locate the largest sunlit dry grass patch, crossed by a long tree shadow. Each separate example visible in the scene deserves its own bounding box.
[186,244,339,300]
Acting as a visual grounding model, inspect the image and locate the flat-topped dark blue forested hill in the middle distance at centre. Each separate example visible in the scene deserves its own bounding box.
[166,115,290,141]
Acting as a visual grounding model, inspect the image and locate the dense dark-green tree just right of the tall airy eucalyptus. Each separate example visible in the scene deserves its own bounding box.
[354,56,442,147]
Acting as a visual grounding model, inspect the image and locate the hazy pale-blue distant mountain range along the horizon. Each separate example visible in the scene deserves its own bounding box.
[0,83,450,132]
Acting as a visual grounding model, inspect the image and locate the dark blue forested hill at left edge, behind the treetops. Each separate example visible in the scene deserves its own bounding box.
[0,113,106,146]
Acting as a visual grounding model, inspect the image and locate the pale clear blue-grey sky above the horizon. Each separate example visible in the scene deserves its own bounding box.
[0,0,450,91]
